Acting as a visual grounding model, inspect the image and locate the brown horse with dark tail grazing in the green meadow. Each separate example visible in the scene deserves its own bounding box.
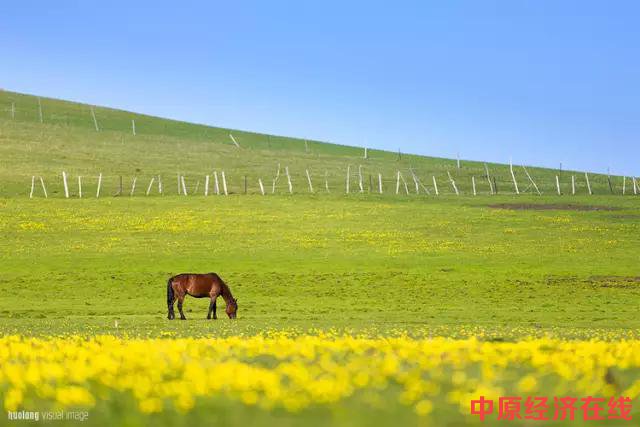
[167,273,238,320]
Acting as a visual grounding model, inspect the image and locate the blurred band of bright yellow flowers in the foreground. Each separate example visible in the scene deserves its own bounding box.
[0,333,640,424]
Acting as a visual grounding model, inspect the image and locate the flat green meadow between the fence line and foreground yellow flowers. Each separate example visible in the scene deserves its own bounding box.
[0,196,640,337]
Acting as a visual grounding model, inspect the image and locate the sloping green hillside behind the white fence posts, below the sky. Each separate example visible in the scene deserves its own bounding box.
[0,91,632,197]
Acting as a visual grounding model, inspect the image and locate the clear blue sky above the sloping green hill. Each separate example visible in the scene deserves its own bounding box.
[0,0,640,175]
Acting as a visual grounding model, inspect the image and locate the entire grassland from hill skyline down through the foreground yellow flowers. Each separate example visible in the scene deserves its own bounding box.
[0,92,640,425]
